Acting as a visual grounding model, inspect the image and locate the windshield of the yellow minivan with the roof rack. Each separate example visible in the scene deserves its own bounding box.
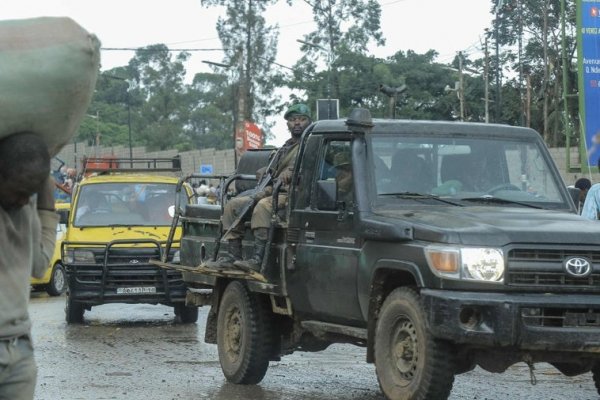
[73,183,188,227]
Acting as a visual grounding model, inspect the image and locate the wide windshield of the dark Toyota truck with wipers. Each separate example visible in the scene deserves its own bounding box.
[371,134,568,208]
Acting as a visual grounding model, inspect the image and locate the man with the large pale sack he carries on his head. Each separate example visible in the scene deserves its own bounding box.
[0,18,100,400]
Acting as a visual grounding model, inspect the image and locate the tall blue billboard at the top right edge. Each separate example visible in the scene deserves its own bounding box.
[577,0,600,169]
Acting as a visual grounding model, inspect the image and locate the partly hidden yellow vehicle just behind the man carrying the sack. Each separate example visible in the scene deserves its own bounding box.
[31,203,71,296]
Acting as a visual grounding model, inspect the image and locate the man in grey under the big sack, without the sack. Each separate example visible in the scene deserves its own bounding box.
[0,133,58,400]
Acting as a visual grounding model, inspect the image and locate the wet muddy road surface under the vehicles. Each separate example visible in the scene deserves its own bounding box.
[30,293,600,400]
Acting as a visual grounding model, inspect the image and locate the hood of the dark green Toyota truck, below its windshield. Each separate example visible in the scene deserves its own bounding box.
[375,206,600,246]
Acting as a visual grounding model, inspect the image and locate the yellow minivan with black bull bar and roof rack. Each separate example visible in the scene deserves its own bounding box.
[62,158,198,323]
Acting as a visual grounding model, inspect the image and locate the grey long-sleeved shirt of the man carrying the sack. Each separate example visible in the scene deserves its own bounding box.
[0,196,58,339]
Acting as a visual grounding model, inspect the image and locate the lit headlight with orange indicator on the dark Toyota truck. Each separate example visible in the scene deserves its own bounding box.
[425,246,504,283]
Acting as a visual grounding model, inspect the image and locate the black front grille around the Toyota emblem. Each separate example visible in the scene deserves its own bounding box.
[506,248,600,291]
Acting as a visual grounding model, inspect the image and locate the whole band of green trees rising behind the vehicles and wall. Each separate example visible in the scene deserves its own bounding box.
[82,0,578,150]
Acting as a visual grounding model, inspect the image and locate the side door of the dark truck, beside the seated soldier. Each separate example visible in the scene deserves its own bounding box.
[288,140,363,324]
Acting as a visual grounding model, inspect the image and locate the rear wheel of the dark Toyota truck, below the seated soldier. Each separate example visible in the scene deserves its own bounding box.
[217,281,273,384]
